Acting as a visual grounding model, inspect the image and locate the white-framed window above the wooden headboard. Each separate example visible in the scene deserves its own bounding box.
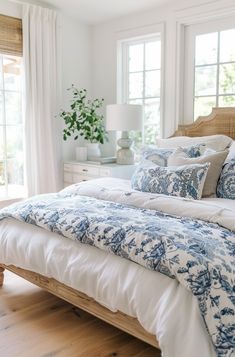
[185,16,235,120]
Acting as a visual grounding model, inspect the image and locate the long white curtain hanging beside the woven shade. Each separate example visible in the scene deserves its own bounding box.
[23,4,59,196]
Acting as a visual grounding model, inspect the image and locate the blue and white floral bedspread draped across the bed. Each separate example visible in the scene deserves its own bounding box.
[0,194,235,357]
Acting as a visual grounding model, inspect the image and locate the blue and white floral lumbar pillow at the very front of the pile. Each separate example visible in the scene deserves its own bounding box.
[131,162,210,200]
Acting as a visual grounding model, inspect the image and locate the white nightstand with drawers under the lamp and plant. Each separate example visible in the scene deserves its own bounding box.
[64,161,136,187]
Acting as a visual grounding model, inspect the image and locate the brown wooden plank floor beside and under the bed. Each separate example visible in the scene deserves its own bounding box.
[0,272,161,357]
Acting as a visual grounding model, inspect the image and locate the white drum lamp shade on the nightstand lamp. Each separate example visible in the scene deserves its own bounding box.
[106,104,143,131]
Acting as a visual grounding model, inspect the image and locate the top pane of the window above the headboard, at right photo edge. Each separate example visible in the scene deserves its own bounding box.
[220,29,235,62]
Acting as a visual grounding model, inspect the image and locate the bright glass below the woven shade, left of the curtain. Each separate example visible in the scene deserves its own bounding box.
[0,55,24,198]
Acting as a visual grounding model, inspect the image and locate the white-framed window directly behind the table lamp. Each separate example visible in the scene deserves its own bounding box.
[122,34,162,148]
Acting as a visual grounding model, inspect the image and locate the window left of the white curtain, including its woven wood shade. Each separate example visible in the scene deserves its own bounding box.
[0,15,25,200]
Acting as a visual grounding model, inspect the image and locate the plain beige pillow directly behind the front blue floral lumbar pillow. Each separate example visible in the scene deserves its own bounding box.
[168,148,228,197]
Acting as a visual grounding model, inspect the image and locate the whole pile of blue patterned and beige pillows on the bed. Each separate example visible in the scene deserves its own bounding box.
[132,135,235,199]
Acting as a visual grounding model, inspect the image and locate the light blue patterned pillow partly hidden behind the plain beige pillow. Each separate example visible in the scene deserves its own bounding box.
[141,144,206,166]
